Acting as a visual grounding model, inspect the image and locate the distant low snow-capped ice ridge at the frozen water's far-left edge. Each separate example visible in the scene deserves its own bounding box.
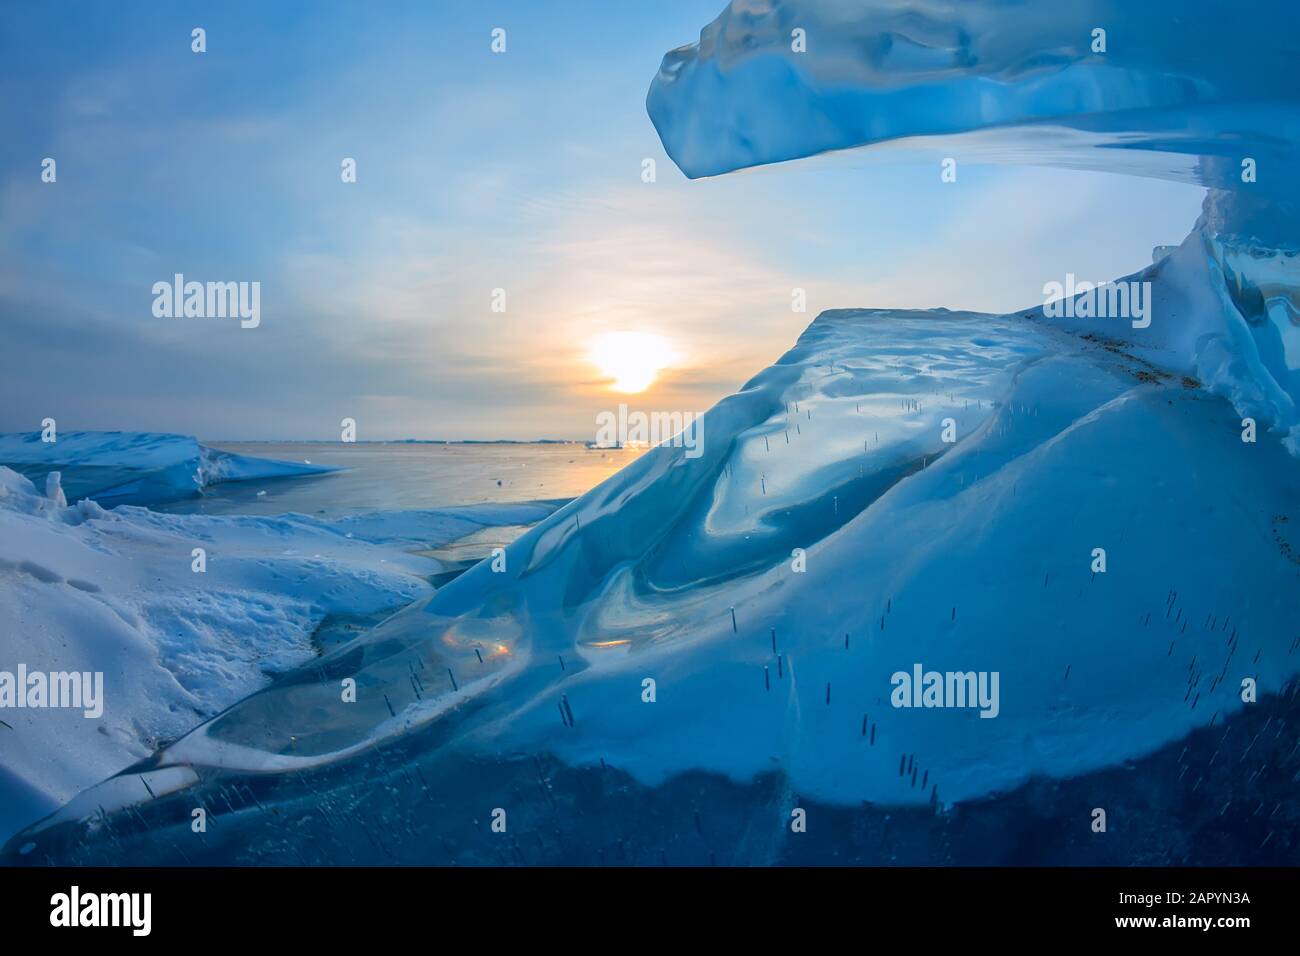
[0,432,335,507]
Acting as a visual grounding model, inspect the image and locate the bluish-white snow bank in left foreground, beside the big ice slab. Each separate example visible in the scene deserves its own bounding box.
[0,468,551,834]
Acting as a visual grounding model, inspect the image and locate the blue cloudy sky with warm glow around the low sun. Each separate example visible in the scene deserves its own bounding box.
[0,0,1204,441]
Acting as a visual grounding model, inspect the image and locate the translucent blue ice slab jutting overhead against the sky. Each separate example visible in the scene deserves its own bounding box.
[646,0,1300,192]
